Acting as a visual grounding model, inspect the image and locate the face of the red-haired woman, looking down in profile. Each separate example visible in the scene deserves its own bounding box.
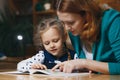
[57,11,86,36]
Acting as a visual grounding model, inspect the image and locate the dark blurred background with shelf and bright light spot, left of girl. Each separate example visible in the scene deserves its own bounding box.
[0,0,55,57]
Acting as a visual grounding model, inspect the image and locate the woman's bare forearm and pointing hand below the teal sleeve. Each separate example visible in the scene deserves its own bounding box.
[52,59,109,74]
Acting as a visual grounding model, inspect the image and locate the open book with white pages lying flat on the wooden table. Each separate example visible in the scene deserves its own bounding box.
[0,69,89,76]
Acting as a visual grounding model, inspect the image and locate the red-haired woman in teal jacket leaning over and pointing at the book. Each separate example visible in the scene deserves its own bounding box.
[53,0,120,74]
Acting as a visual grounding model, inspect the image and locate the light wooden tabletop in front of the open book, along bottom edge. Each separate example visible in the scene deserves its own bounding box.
[0,70,120,80]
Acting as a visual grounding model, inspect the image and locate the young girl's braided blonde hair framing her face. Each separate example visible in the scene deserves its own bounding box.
[37,18,66,48]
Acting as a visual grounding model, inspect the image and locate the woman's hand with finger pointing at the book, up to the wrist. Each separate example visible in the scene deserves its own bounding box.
[52,59,86,73]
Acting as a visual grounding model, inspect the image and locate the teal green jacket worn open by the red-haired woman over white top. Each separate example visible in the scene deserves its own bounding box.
[69,9,120,74]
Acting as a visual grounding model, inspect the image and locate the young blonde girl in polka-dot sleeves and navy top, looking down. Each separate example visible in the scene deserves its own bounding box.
[17,18,75,72]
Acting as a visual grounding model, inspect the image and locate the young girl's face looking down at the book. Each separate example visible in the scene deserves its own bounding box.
[41,28,64,57]
